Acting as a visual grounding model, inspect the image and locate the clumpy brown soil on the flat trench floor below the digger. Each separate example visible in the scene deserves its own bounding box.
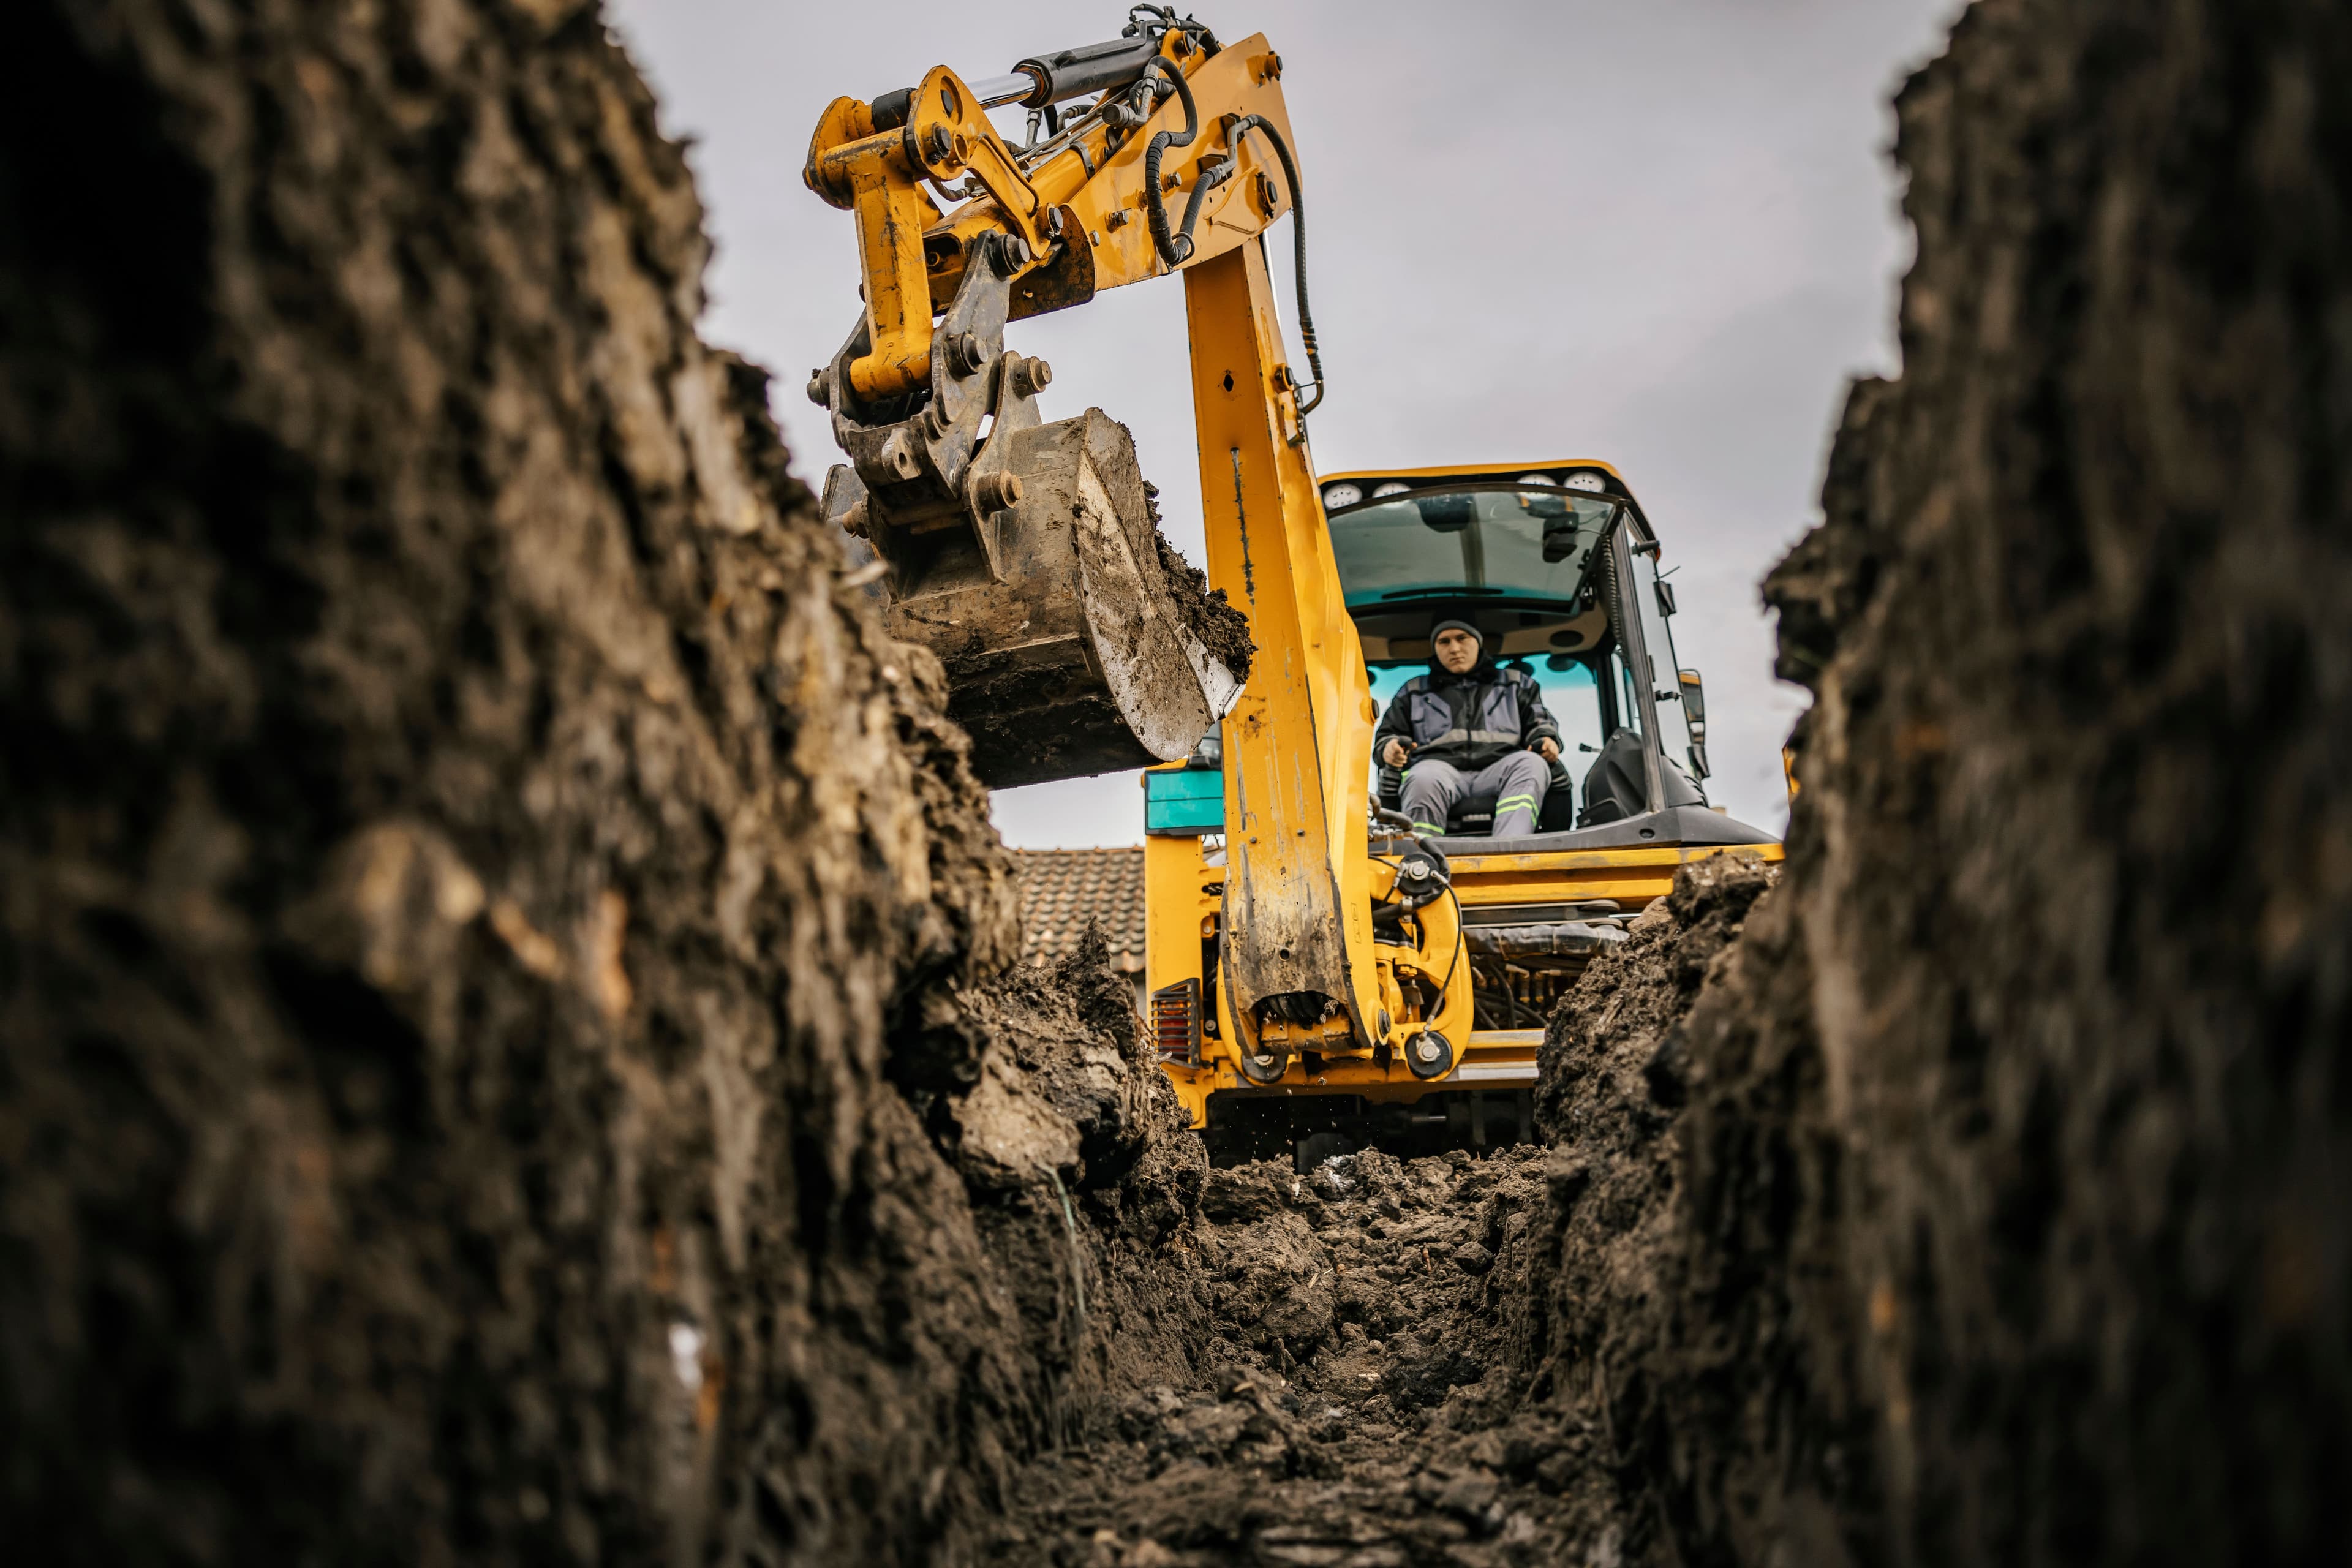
[988,1150,1578,1568]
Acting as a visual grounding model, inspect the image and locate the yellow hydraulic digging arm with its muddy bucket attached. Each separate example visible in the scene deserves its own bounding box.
[804,7,1470,1084]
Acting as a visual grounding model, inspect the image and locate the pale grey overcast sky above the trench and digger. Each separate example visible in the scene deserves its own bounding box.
[607,0,1959,849]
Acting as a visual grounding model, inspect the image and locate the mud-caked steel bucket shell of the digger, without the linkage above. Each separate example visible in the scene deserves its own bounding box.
[826,411,1251,788]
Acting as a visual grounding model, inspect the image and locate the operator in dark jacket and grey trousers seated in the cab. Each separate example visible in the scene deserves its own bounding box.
[1371,620,1559,839]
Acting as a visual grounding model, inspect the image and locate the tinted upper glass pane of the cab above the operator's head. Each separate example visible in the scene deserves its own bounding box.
[1331,484,1621,609]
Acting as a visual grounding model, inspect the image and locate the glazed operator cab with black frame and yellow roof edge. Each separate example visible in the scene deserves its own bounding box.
[1322,461,1773,853]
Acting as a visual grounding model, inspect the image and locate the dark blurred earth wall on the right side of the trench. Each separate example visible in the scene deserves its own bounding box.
[1531,0,2352,1563]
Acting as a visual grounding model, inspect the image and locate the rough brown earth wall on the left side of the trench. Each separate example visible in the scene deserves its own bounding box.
[0,0,1197,1563]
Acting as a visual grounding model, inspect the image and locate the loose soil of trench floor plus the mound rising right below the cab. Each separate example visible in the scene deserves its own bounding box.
[988,858,1771,1568]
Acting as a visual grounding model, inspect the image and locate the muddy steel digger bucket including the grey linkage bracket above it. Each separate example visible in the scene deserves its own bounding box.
[809,219,1249,788]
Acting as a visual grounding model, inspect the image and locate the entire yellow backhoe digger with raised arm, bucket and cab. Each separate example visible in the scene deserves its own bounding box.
[804,5,1781,1161]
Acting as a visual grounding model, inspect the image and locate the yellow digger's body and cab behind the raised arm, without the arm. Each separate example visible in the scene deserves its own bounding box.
[1143,458,1781,1169]
